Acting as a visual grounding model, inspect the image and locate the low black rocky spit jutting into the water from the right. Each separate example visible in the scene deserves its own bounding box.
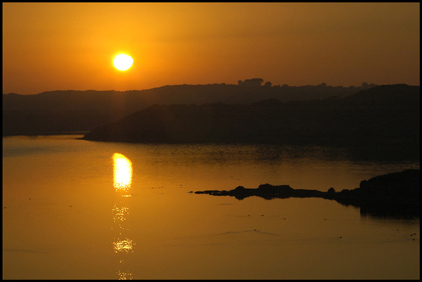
[194,169,420,218]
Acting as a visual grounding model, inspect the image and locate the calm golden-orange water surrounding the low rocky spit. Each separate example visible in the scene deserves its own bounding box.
[3,136,420,279]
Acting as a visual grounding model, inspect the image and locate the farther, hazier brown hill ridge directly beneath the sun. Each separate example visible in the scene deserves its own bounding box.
[3,83,369,136]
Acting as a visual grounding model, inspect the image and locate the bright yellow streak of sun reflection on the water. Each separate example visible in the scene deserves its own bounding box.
[111,153,135,280]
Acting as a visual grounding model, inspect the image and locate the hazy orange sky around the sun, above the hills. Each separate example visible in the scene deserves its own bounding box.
[3,3,420,94]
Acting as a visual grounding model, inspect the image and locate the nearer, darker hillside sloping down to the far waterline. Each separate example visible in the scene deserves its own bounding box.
[84,85,420,159]
